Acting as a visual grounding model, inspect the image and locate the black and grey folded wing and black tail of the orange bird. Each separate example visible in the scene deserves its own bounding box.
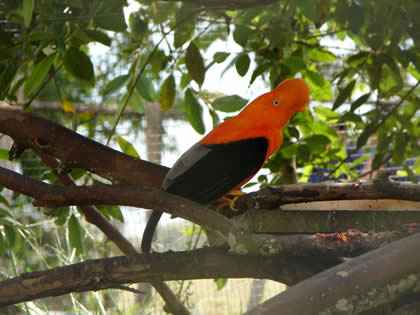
[141,138,268,253]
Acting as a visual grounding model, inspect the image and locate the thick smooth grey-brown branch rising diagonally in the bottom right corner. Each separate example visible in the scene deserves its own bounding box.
[246,233,420,315]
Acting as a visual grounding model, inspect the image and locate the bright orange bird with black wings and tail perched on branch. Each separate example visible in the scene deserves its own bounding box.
[141,79,309,253]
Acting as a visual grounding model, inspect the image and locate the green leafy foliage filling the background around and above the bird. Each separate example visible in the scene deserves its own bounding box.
[0,0,420,312]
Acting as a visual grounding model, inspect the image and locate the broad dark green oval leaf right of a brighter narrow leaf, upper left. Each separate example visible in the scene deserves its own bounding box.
[64,47,95,84]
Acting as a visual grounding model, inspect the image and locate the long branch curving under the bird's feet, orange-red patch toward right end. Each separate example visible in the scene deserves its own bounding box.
[0,168,418,257]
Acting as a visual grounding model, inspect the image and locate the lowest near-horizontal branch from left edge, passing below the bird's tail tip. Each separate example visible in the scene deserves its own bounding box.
[0,248,331,306]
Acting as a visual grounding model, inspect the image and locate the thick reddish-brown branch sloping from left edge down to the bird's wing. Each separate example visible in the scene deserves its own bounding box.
[0,102,168,187]
